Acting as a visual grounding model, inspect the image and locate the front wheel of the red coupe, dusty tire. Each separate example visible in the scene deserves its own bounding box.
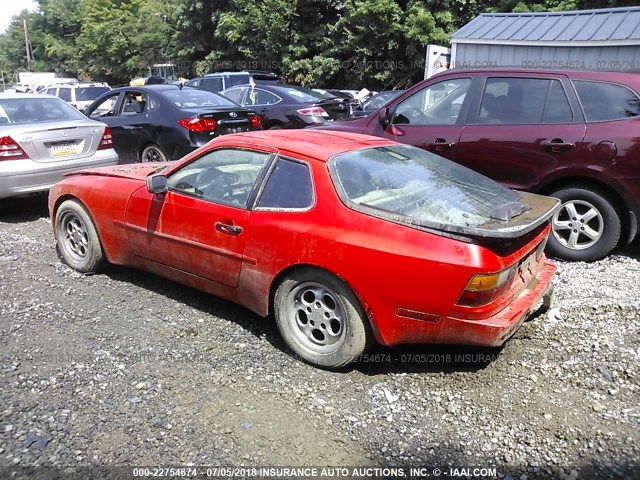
[55,200,107,273]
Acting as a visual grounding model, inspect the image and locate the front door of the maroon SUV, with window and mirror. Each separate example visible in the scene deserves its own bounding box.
[364,77,472,158]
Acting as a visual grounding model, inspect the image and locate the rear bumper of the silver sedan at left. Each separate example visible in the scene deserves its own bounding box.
[0,150,118,198]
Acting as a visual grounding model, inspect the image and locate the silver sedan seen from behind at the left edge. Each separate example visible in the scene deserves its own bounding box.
[0,93,118,198]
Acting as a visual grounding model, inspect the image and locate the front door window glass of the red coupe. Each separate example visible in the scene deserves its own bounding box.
[167,148,271,208]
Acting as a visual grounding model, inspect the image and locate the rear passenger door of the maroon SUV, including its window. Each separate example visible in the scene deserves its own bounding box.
[453,74,586,190]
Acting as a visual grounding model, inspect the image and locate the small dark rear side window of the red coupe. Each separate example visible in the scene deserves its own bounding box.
[257,158,314,209]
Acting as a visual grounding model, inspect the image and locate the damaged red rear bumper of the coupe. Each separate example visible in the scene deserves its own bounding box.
[435,260,556,347]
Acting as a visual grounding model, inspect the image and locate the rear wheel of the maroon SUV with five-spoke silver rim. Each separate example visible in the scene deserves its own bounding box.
[547,187,622,262]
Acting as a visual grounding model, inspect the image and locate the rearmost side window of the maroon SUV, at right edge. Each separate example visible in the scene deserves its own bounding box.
[573,80,640,123]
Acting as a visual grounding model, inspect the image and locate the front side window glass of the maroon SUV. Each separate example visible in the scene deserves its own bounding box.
[391,78,471,125]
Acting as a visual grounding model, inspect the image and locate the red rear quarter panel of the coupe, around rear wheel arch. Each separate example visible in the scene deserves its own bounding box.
[238,152,512,343]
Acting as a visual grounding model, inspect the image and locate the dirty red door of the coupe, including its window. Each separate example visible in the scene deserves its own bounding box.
[126,148,272,287]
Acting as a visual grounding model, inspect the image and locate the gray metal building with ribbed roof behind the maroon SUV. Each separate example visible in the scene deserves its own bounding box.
[451,7,640,70]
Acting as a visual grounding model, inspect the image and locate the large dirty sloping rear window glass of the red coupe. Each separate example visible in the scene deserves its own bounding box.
[329,145,520,227]
